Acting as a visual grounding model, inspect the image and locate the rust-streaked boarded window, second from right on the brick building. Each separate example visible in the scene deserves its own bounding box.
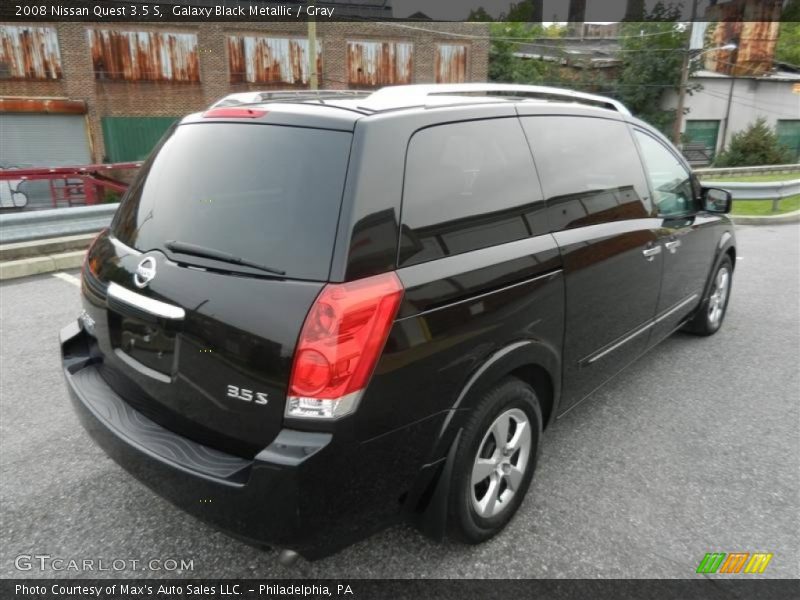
[347,42,414,88]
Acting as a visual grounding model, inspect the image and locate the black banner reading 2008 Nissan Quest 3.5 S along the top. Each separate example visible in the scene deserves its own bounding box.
[0,0,800,23]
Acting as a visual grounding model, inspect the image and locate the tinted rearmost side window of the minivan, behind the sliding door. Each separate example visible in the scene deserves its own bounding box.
[399,118,548,266]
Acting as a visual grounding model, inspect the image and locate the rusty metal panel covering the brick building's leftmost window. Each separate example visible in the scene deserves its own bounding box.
[0,25,62,80]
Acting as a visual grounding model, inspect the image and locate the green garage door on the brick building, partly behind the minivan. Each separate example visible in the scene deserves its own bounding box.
[103,117,178,162]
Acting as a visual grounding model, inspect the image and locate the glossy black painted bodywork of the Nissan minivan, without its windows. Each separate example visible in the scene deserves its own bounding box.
[62,97,735,558]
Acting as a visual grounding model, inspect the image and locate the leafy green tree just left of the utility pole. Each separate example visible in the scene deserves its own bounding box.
[614,2,697,133]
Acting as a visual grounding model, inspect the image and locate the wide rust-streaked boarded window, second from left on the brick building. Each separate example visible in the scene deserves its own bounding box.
[88,29,200,82]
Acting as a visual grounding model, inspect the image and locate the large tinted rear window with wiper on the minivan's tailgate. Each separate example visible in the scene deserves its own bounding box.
[112,123,352,280]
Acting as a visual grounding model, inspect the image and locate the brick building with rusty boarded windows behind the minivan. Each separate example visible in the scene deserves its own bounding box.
[0,22,489,168]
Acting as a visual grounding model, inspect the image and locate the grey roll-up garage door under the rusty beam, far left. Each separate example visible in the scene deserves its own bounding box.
[0,114,92,168]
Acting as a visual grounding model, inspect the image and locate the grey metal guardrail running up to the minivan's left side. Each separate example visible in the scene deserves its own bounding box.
[0,203,119,244]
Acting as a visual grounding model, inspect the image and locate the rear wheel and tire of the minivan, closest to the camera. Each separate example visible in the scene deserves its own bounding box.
[449,377,542,544]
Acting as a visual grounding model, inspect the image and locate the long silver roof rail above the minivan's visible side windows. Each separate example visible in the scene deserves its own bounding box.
[367,83,631,115]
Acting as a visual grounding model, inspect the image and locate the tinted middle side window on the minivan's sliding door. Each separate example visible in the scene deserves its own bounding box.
[522,116,652,230]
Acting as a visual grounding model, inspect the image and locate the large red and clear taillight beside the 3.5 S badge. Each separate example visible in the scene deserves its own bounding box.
[286,273,403,419]
